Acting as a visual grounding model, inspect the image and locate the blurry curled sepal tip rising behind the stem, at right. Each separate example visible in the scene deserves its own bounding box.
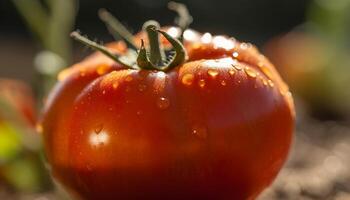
[168,1,193,42]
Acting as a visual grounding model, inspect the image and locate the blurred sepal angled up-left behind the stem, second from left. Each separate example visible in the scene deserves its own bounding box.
[98,9,137,50]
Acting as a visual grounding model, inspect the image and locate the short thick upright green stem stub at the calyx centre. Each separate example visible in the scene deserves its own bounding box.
[143,20,165,65]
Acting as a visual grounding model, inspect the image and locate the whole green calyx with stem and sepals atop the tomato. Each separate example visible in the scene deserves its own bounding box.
[71,2,192,71]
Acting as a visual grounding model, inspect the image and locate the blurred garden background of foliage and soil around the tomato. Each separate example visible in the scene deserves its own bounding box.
[0,0,350,200]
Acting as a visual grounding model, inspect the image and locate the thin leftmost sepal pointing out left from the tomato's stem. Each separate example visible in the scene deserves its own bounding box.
[70,31,132,68]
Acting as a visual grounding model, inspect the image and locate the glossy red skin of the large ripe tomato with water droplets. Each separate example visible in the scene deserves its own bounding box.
[43,27,294,199]
